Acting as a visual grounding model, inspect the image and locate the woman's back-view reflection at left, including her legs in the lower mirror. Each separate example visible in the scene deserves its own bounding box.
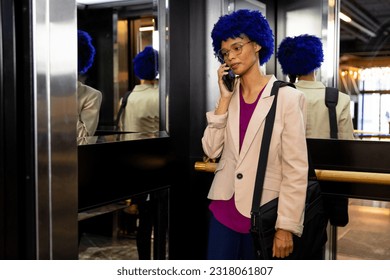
[119,46,161,260]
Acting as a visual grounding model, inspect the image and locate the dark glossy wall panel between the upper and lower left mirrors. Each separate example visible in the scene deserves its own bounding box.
[78,137,173,211]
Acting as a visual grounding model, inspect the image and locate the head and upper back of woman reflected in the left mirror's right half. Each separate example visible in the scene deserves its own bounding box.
[119,46,160,132]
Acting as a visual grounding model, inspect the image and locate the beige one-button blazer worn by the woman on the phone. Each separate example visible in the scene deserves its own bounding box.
[202,76,308,236]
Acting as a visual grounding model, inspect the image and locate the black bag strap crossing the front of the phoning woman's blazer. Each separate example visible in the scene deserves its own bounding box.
[251,81,295,217]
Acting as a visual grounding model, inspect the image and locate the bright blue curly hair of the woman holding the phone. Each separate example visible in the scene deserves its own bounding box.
[211,9,274,65]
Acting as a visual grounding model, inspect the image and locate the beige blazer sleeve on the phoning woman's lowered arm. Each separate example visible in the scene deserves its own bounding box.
[276,90,308,236]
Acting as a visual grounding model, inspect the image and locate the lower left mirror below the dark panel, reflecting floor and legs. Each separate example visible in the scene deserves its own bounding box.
[78,188,169,260]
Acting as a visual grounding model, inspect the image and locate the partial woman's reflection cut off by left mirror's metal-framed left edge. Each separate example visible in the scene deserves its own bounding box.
[77,30,102,143]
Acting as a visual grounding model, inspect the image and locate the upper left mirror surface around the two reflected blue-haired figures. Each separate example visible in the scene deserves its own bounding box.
[77,0,168,144]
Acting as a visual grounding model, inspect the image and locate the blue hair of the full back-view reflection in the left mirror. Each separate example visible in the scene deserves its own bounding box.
[133,46,158,80]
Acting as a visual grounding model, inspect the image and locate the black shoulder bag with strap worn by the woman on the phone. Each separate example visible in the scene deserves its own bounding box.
[250,81,327,260]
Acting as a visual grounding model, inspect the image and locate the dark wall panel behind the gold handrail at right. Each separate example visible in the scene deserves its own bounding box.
[307,139,390,201]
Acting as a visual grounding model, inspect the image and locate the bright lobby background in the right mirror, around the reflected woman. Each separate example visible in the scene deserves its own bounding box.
[284,0,390,140]
